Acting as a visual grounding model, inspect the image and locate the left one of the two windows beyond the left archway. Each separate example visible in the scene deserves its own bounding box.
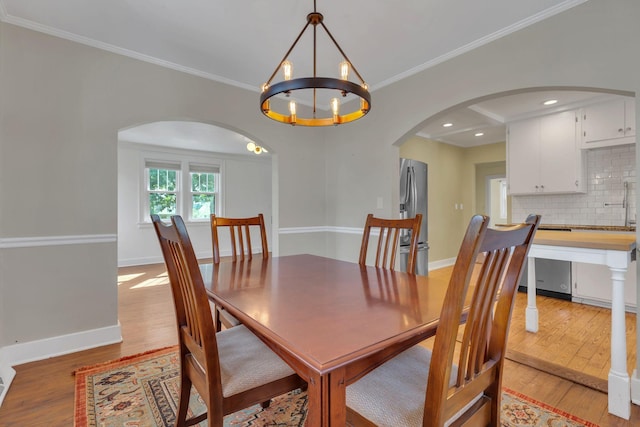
[145,161,180,219]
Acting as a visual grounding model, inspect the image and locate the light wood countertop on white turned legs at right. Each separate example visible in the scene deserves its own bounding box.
[533,230,636,251]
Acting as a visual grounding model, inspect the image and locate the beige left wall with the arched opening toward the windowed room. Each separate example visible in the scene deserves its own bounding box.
[0,23,326,359]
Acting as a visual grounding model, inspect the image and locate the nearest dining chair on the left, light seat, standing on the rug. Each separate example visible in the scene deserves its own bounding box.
[151,215,306,427]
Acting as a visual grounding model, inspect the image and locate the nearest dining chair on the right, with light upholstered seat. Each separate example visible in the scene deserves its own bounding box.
[346,215,540,427]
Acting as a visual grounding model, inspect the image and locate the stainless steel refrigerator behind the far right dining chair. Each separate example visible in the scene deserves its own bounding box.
[400,158,429,276]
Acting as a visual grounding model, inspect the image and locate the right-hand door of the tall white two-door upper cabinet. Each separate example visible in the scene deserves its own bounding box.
[540,111,580,193]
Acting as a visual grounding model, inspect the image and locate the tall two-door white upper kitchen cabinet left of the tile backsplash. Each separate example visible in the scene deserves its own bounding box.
[507,110,585,195]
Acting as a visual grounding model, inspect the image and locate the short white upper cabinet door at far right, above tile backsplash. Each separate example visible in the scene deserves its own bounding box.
[582,99,625,145]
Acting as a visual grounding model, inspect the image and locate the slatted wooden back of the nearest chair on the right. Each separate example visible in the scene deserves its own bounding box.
[424,215,540,426]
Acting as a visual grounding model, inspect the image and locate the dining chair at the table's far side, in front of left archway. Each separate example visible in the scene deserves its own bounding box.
[211,213,269,331]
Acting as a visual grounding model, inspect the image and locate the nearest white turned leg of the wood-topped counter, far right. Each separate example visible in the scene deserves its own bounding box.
[608,267,631,420]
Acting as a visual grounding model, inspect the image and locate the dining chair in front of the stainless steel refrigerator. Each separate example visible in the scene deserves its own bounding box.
[358,214,422,274]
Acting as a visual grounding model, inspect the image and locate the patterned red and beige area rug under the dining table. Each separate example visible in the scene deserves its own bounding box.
[74,347,597,427]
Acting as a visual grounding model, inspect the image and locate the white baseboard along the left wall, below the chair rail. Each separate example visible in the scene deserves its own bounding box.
[0,323,122,366]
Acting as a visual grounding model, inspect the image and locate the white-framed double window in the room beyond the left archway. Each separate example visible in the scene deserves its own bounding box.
[142,160,220,222]
